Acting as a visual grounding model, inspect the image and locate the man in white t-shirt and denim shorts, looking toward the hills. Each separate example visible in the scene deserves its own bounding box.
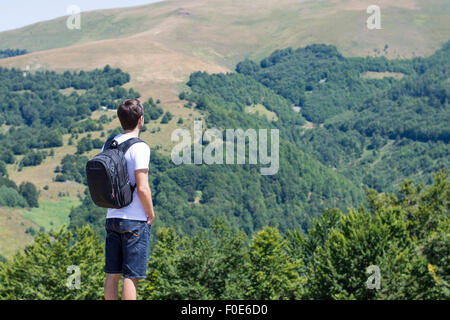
[105,99,155,300]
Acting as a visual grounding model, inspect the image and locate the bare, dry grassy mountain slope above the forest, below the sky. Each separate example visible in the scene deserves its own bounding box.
[0,0,450,99]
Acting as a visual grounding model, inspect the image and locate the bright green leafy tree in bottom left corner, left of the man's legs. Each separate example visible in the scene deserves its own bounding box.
[0,226,104,300]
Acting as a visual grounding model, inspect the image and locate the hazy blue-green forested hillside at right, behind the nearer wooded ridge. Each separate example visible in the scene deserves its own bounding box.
[234,42,450,191]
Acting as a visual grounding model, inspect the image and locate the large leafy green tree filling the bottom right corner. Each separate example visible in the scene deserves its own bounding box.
[305,171,450,299]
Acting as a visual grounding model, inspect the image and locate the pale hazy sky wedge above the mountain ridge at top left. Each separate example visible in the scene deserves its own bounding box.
[0,0,160,31]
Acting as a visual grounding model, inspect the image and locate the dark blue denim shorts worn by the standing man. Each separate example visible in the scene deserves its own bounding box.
[105,218,151,279]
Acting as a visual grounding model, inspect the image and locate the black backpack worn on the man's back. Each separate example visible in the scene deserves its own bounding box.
[86,137,143,209]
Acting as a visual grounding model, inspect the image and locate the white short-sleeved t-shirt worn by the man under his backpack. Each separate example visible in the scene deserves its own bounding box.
[102,133,150,221]
